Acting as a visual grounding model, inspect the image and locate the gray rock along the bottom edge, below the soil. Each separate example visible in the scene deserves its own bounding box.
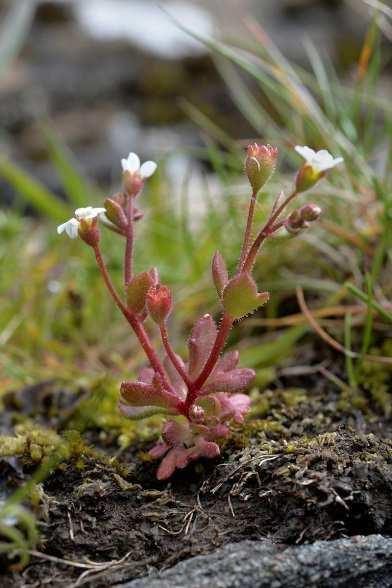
[121,535,392,588]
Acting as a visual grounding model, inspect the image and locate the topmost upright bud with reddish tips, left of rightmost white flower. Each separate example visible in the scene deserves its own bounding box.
[245,143,278,194]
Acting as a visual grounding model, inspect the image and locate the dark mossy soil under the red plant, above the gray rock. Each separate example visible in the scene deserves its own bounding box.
[1,360,392,588]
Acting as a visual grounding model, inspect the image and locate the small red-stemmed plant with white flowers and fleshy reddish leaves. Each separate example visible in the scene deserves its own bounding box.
[57,143,342,480]
